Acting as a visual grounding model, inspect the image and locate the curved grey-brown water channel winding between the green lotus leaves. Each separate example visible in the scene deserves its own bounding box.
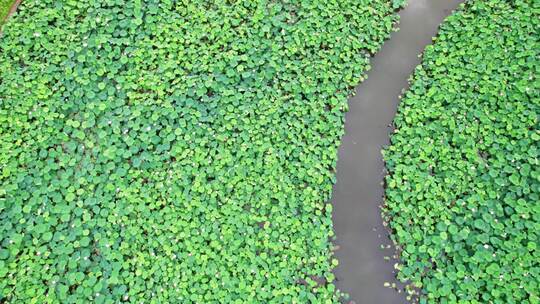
[332,0,463,304]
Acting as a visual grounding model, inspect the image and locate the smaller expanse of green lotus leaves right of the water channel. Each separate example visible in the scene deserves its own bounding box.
[385,0,540,304]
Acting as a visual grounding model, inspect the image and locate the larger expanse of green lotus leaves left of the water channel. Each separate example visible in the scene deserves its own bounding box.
[0,0,401,303]
